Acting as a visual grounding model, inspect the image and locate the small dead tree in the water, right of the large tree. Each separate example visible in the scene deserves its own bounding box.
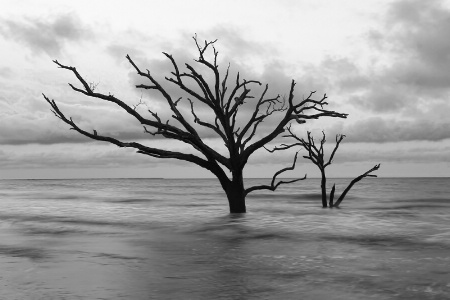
[267,127,380,207]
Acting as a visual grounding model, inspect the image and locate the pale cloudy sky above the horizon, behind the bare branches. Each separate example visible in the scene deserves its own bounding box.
[0,0,450,179]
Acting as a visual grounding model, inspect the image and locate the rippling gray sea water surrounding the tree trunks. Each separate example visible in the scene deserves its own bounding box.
[0,178,450,300]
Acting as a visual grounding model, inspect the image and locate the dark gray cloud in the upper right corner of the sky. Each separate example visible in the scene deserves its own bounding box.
[387,0,450,89]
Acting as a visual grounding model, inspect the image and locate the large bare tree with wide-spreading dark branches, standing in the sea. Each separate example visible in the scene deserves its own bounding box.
[43,36,347,213]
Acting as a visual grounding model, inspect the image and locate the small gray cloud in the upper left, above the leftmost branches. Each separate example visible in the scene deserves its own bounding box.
[0,14,93,57]
